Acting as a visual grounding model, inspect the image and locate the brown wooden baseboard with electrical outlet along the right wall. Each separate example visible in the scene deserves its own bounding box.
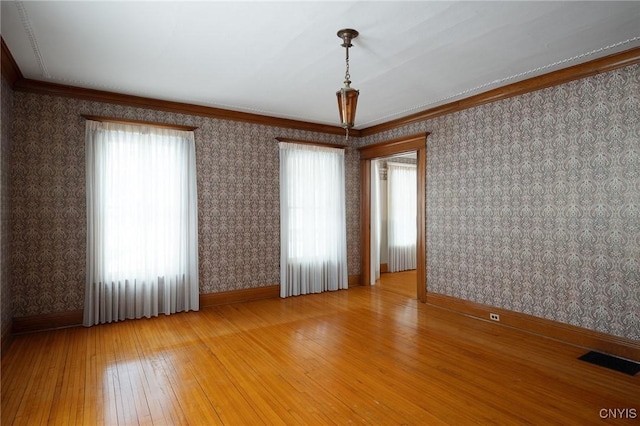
[427,293,640,361]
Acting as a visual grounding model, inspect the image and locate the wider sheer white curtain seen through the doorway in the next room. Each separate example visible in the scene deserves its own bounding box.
[387,163,418,272]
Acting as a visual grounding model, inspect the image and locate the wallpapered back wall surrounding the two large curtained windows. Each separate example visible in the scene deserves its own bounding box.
[11,92,360,317]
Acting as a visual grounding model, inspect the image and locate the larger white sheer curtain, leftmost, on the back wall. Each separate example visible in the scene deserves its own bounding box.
[84,121,199,326]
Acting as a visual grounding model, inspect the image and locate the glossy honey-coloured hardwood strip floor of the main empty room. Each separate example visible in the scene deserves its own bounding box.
[2,286,640,426]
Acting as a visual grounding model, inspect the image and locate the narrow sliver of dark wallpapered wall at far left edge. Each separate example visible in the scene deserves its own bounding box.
[0,73,13,332]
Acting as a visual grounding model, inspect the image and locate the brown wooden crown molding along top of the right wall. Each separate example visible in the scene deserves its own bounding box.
[360,47,640,137]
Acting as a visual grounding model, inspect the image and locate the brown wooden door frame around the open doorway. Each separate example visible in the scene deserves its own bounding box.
[358,132,429,303]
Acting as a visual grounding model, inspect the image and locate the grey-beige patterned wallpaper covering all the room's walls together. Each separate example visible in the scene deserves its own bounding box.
[3,61,640,340]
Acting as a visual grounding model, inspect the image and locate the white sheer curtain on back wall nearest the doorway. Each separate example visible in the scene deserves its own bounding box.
[280,142,348,297]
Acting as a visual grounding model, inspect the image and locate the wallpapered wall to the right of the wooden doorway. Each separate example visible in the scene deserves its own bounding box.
[360,65,640,340]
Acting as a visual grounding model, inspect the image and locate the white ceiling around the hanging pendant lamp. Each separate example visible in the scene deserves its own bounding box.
[0,1,640,128]
